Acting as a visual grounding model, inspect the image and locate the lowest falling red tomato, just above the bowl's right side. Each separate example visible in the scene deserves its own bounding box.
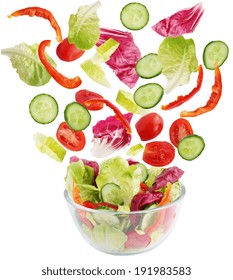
[142,141,175,166]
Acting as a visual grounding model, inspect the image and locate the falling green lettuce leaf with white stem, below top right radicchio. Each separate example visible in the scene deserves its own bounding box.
[158,36,198,93]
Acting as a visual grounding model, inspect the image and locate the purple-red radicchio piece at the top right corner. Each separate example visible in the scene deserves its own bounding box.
[152,3,204,37]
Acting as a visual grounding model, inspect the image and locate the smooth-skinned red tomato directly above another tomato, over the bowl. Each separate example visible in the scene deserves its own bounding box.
[135,113,163,141]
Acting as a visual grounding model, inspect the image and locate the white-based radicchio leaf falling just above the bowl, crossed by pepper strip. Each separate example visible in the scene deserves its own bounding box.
[91,113,133,158]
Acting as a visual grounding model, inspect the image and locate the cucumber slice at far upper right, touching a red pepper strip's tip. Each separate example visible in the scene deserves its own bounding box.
[203,41,229,70]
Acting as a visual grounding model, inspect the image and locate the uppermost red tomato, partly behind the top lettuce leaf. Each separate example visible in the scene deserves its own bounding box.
[56,38,85,62]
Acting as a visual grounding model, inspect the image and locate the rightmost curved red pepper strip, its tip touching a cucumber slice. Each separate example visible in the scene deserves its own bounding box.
[180,65,222,117]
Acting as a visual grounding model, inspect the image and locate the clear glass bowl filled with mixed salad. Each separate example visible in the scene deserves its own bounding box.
[65,156,185,254]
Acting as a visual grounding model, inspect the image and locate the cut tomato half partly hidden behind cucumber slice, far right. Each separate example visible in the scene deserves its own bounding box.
[169,118,193,147]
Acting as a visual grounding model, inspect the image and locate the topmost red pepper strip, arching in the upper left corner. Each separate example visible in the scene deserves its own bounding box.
[8,7,62,43]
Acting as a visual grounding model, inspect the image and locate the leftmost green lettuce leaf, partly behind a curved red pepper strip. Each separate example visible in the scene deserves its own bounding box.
[1,43,56,86]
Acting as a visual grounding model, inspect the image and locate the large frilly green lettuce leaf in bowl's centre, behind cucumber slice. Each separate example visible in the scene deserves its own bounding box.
[96,156,141,205]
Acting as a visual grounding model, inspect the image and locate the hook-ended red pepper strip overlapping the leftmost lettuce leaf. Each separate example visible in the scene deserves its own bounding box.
[38,40,82,89]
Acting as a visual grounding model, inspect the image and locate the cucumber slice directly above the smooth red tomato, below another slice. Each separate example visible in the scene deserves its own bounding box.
[133,83,164,109]
